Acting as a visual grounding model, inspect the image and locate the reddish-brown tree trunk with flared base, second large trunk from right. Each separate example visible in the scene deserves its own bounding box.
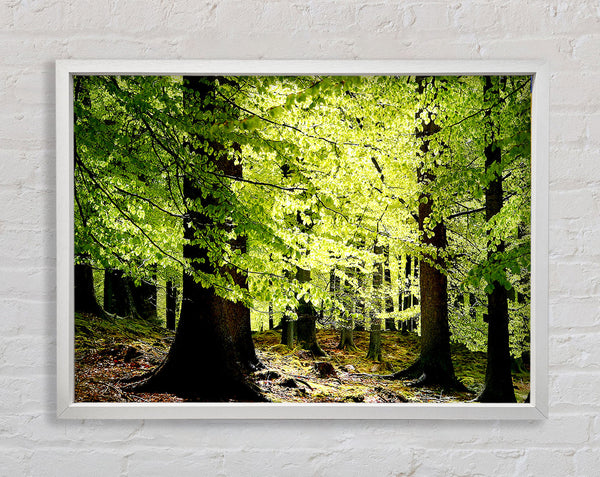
[394,77,464,389]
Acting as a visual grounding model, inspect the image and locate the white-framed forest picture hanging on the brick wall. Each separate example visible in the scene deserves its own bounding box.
[56,60,549,419]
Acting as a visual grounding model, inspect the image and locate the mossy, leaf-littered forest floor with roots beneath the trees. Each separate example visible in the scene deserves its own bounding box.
[75,315,529,403]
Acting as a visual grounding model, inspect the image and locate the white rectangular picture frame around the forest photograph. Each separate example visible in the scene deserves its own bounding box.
[56,60,549,419]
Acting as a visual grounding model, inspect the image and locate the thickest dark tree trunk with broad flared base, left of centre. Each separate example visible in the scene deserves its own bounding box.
[129,77,265,401]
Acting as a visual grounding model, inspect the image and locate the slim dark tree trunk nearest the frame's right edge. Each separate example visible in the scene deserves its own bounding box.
[477,76,516,402]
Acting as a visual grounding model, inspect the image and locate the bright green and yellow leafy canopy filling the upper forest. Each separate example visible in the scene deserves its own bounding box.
[74,76,531,355]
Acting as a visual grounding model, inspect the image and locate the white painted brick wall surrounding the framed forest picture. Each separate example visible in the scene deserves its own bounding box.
[0,0,600,477]
